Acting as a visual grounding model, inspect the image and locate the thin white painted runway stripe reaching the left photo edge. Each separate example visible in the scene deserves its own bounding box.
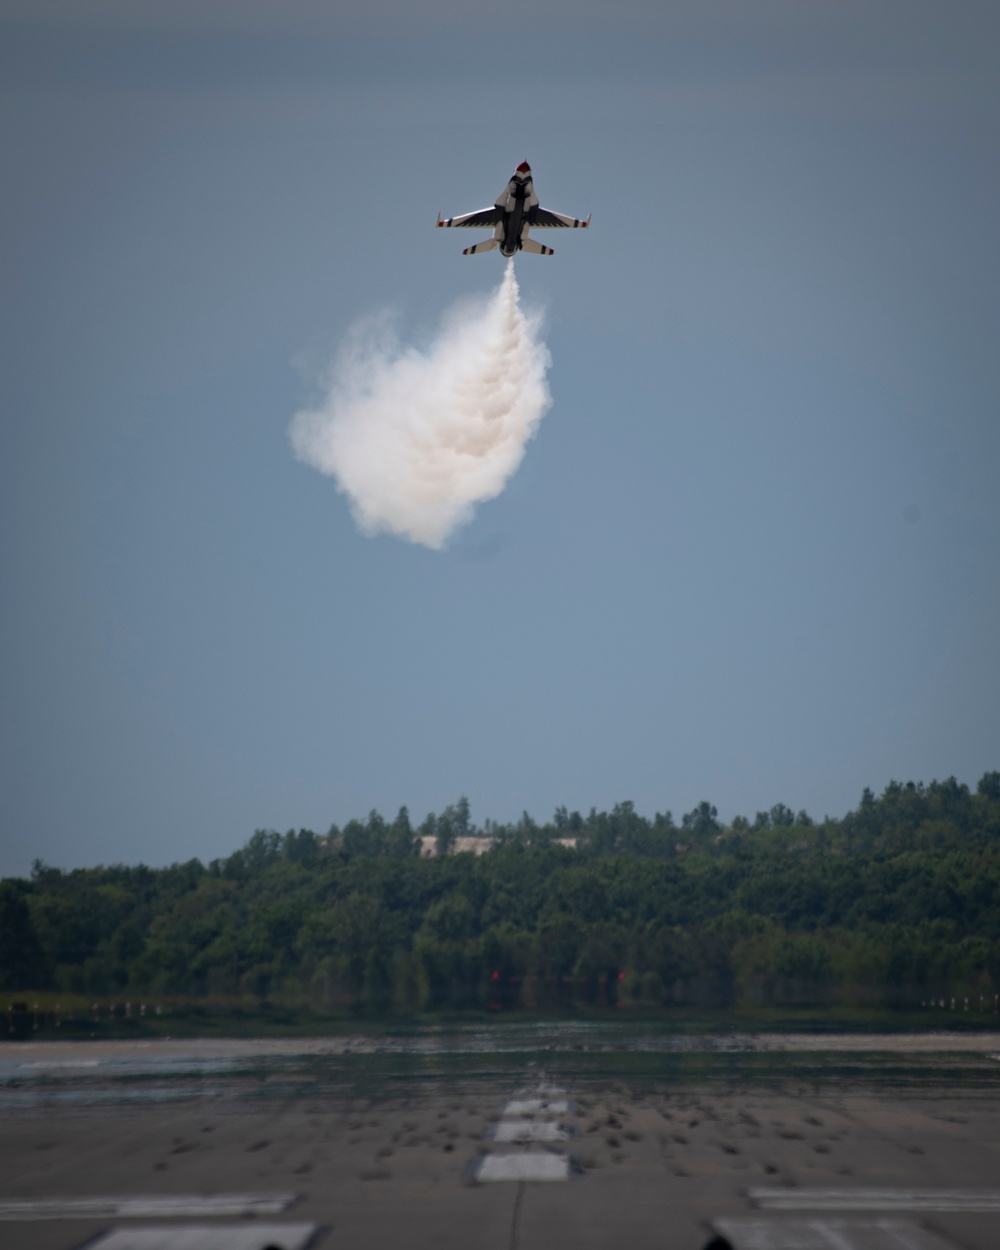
[0,1194,295,1220]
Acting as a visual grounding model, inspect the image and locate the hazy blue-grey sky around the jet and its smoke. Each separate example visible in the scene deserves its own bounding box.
[0,0,1000,874]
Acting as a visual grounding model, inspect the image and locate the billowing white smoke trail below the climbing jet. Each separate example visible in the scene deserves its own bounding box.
[289,263,551,549]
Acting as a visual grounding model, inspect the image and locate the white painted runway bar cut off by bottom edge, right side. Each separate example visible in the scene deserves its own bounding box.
[713,1219,955,1250]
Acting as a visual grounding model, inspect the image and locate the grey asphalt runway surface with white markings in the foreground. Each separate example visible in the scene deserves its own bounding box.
[0,1030,1000,1250]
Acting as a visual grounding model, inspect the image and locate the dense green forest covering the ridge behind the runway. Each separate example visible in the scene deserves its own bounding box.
[0,773,1000,1013]
